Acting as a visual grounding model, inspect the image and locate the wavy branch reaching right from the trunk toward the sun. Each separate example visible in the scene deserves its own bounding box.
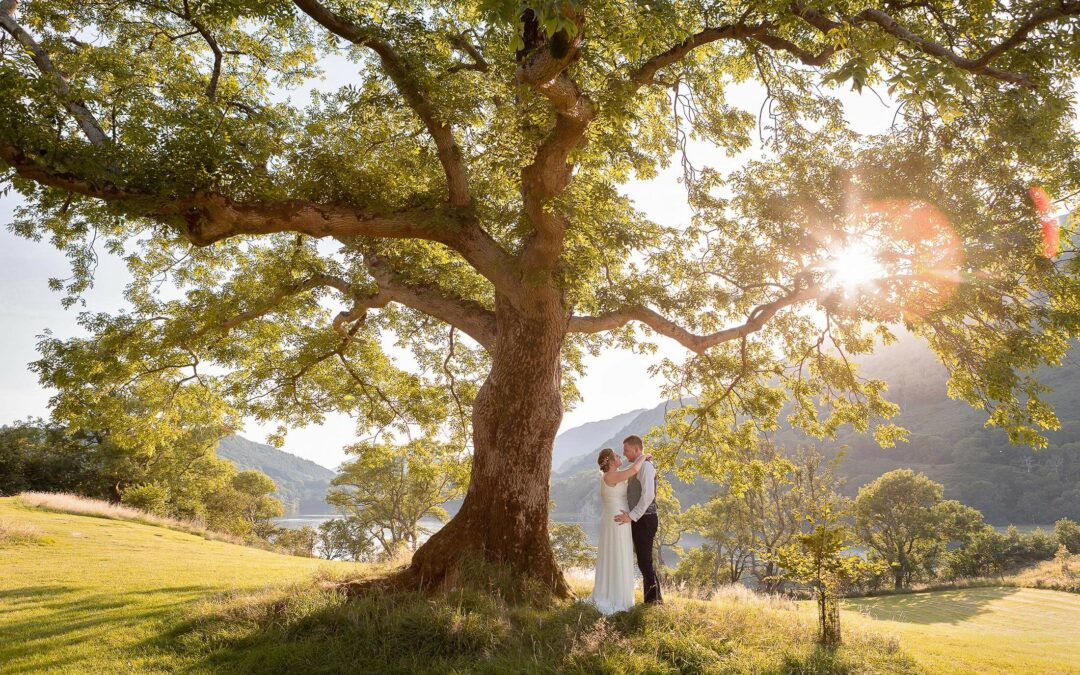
[568,286,821,354]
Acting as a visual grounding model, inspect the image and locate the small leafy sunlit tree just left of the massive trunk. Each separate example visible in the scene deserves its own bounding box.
[325,438,469,559]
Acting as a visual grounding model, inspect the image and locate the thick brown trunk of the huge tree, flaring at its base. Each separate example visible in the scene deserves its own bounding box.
[403,297,571,597]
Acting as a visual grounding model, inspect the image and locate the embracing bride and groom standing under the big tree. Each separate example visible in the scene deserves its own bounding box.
[589,436,662,615]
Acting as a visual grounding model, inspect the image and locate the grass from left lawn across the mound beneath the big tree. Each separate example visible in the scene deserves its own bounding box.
[0,499,919,674]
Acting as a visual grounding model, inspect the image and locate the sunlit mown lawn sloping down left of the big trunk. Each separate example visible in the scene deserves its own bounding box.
[0,498,355,673]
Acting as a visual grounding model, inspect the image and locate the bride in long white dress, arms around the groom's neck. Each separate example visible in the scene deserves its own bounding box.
[589,448,649,615]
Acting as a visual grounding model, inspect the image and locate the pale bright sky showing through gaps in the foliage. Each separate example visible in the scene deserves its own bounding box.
[0,47,1049,468]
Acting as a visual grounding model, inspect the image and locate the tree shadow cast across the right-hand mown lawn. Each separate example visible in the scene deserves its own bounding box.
[845,586,1020,623]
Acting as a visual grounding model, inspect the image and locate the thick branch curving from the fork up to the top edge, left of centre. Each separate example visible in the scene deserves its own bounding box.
[294,0,472,207]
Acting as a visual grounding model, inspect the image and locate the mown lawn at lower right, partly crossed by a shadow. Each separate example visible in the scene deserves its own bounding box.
[841,586,1080,673]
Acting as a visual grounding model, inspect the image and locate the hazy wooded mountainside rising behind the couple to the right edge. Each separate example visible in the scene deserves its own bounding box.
[552,335,1080,524]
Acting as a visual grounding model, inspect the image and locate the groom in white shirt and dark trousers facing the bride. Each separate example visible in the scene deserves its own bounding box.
[615,436,663,605]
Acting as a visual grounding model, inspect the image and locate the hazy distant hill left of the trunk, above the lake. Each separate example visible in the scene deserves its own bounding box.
[217,436,335,515]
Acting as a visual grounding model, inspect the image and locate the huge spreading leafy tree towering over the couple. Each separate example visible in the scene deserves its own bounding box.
[0,0,1080,592]
